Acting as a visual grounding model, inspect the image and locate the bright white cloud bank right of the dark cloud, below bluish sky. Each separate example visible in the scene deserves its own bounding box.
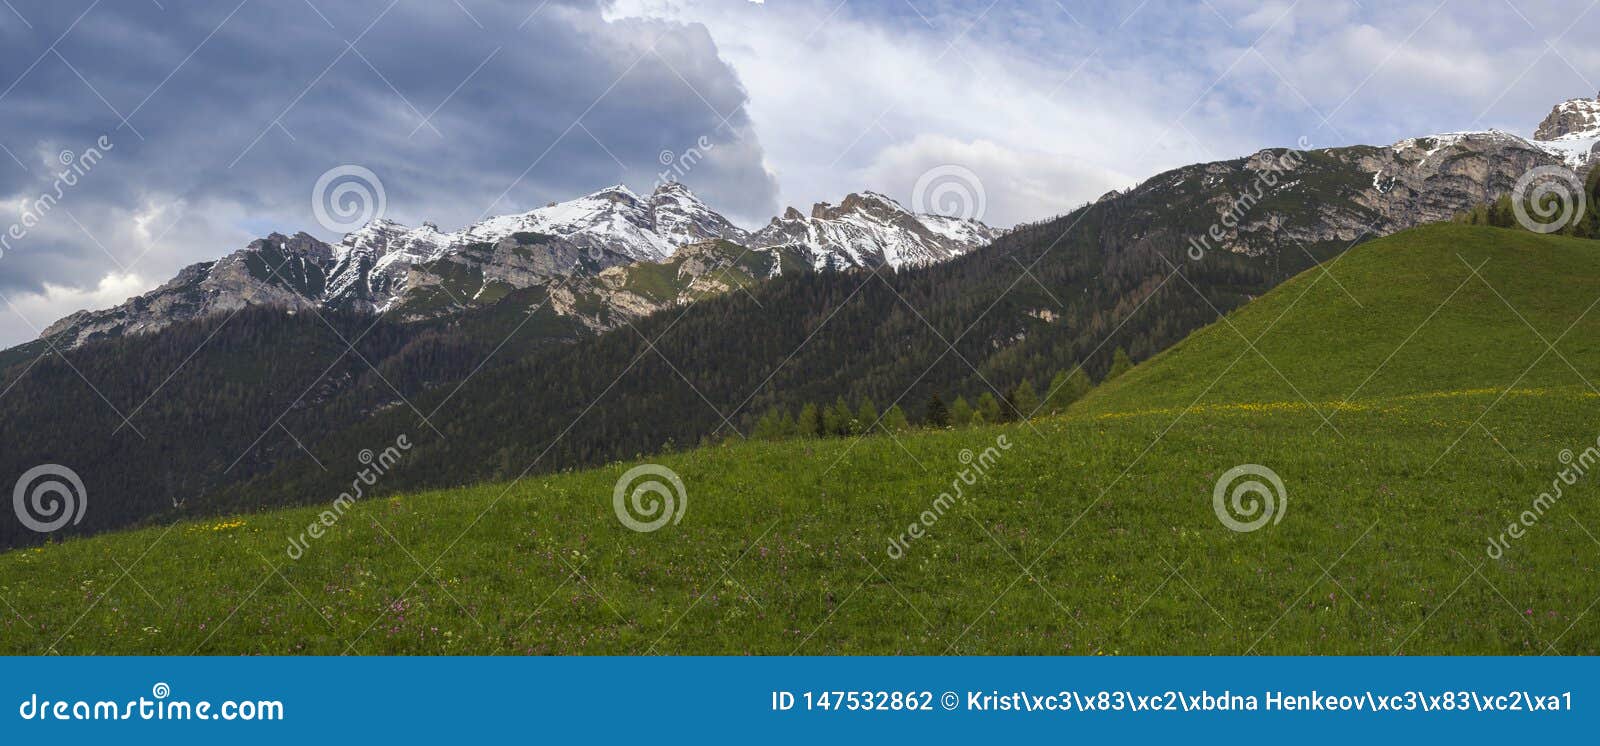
[611,0,1251,226]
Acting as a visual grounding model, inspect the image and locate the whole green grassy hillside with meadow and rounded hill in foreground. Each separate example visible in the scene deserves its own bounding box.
[0,226,1600,655]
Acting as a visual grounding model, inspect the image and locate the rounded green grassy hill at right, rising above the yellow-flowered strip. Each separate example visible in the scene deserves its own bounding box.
[1080,224,1600,413]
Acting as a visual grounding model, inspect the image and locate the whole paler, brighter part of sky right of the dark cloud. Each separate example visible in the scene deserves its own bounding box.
[610,0,1600,224]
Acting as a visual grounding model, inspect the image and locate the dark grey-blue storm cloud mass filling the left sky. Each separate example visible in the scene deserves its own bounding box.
[0,0,776,299]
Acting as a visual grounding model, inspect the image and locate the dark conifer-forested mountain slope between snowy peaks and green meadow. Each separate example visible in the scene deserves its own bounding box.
[0,96,1593,546]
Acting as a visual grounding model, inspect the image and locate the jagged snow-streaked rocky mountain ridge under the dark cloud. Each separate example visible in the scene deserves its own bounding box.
[43,182,1002,349]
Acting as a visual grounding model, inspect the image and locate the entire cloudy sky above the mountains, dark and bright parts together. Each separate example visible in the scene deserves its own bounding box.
[0,0,1600,346]
